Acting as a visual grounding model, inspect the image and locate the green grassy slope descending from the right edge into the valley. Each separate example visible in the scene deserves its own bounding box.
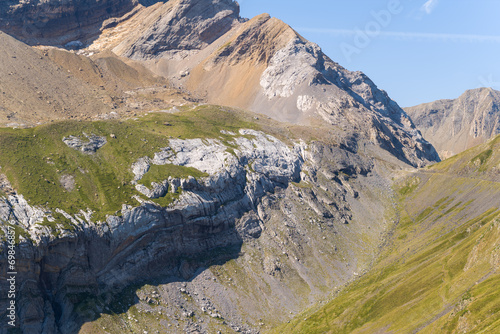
[274,137,500,333]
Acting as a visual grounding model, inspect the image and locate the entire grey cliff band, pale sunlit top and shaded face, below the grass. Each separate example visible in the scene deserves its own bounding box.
[0,130,303,333]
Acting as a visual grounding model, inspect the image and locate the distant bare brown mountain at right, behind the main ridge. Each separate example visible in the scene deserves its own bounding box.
[405,88,500,159]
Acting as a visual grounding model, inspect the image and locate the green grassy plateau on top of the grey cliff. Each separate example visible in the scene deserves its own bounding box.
[0,106,266,226]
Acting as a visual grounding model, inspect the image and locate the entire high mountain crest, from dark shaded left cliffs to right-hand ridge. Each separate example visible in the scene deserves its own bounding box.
[0,0,439,166]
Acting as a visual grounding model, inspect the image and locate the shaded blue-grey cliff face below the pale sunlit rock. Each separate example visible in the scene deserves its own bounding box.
[9,190,264,334]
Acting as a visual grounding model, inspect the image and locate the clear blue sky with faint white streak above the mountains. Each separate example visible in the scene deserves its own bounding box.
[238,0,500,107]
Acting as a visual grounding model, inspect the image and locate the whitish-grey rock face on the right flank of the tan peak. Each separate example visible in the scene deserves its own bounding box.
[260,38,439,166]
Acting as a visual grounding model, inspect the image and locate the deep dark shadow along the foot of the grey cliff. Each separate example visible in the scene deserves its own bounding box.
[39,220,243,334]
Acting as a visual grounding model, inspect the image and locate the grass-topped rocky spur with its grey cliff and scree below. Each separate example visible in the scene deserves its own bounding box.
[0,106,397,333]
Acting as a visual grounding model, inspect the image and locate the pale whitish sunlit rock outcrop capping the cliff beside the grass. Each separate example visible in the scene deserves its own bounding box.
[132,129,306,197]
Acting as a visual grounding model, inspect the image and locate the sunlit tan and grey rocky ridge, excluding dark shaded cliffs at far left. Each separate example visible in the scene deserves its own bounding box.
[88,1,439,166]
